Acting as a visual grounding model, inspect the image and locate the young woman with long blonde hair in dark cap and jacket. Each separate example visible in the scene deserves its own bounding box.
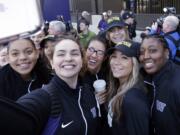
[107,40,150,135]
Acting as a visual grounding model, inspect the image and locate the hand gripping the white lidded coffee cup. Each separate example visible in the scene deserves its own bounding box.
[95,90,107,105]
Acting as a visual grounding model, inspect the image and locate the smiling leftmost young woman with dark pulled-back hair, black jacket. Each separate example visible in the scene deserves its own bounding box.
[0,39,51,100]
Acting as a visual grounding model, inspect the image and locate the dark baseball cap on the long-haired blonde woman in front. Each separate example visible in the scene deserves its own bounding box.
[106,40,140,58]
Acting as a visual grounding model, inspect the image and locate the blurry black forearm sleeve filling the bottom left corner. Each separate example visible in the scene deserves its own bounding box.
[0,97,38,135]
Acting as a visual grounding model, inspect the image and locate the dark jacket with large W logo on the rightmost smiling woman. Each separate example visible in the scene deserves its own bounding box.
[145,61,180,135]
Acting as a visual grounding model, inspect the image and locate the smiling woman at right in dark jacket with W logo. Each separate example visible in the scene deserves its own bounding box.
[139,35,180,135]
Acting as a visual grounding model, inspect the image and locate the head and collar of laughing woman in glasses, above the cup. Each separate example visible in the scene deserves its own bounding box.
[84,36,108,89]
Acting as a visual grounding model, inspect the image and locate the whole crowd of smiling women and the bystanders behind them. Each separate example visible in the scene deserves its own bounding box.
[0,7,180,135]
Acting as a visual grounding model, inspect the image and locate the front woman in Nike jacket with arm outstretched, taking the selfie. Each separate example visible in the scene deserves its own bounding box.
[18,38,98,135]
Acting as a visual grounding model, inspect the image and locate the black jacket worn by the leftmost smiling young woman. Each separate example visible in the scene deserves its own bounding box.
[0,64,50,100]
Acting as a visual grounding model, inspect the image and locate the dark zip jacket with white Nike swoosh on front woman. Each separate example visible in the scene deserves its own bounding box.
[17,76,99,135]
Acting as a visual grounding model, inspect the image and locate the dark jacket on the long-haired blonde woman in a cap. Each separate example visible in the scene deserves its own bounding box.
[111,84,150,135]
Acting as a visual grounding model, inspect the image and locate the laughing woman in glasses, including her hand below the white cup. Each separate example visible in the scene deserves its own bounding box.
[84,36,108,135]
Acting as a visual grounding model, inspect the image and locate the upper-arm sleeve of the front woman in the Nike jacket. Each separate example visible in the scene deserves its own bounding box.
[17,89,51,133]
